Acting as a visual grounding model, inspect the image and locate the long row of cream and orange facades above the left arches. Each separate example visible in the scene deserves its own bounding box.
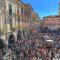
[0,0,40,44]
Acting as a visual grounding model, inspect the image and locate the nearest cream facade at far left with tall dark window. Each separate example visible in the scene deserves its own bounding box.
[0,0,16,43]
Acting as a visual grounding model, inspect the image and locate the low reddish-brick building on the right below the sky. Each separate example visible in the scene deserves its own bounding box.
[43,15,60,30]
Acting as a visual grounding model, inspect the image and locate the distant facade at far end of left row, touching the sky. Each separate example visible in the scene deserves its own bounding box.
[31,11,42,28]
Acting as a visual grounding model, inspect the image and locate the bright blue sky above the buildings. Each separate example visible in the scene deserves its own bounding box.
[21,0,59,18]
